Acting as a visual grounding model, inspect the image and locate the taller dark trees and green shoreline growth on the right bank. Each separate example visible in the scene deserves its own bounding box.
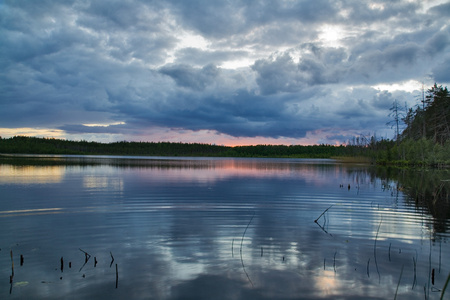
[365,83,450,167]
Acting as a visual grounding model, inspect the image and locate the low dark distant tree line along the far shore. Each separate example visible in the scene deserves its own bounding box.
[0,136,361,158]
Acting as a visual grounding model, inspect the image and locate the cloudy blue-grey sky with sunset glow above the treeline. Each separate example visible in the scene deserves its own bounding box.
[0,0,450,146]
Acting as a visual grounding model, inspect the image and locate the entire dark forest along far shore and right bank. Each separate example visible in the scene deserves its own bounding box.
[0,84,450,167]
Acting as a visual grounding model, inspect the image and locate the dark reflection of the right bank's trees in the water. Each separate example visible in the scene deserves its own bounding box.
[377,168,450,233]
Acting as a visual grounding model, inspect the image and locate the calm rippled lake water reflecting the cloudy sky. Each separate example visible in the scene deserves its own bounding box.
[0,156,450,299]
